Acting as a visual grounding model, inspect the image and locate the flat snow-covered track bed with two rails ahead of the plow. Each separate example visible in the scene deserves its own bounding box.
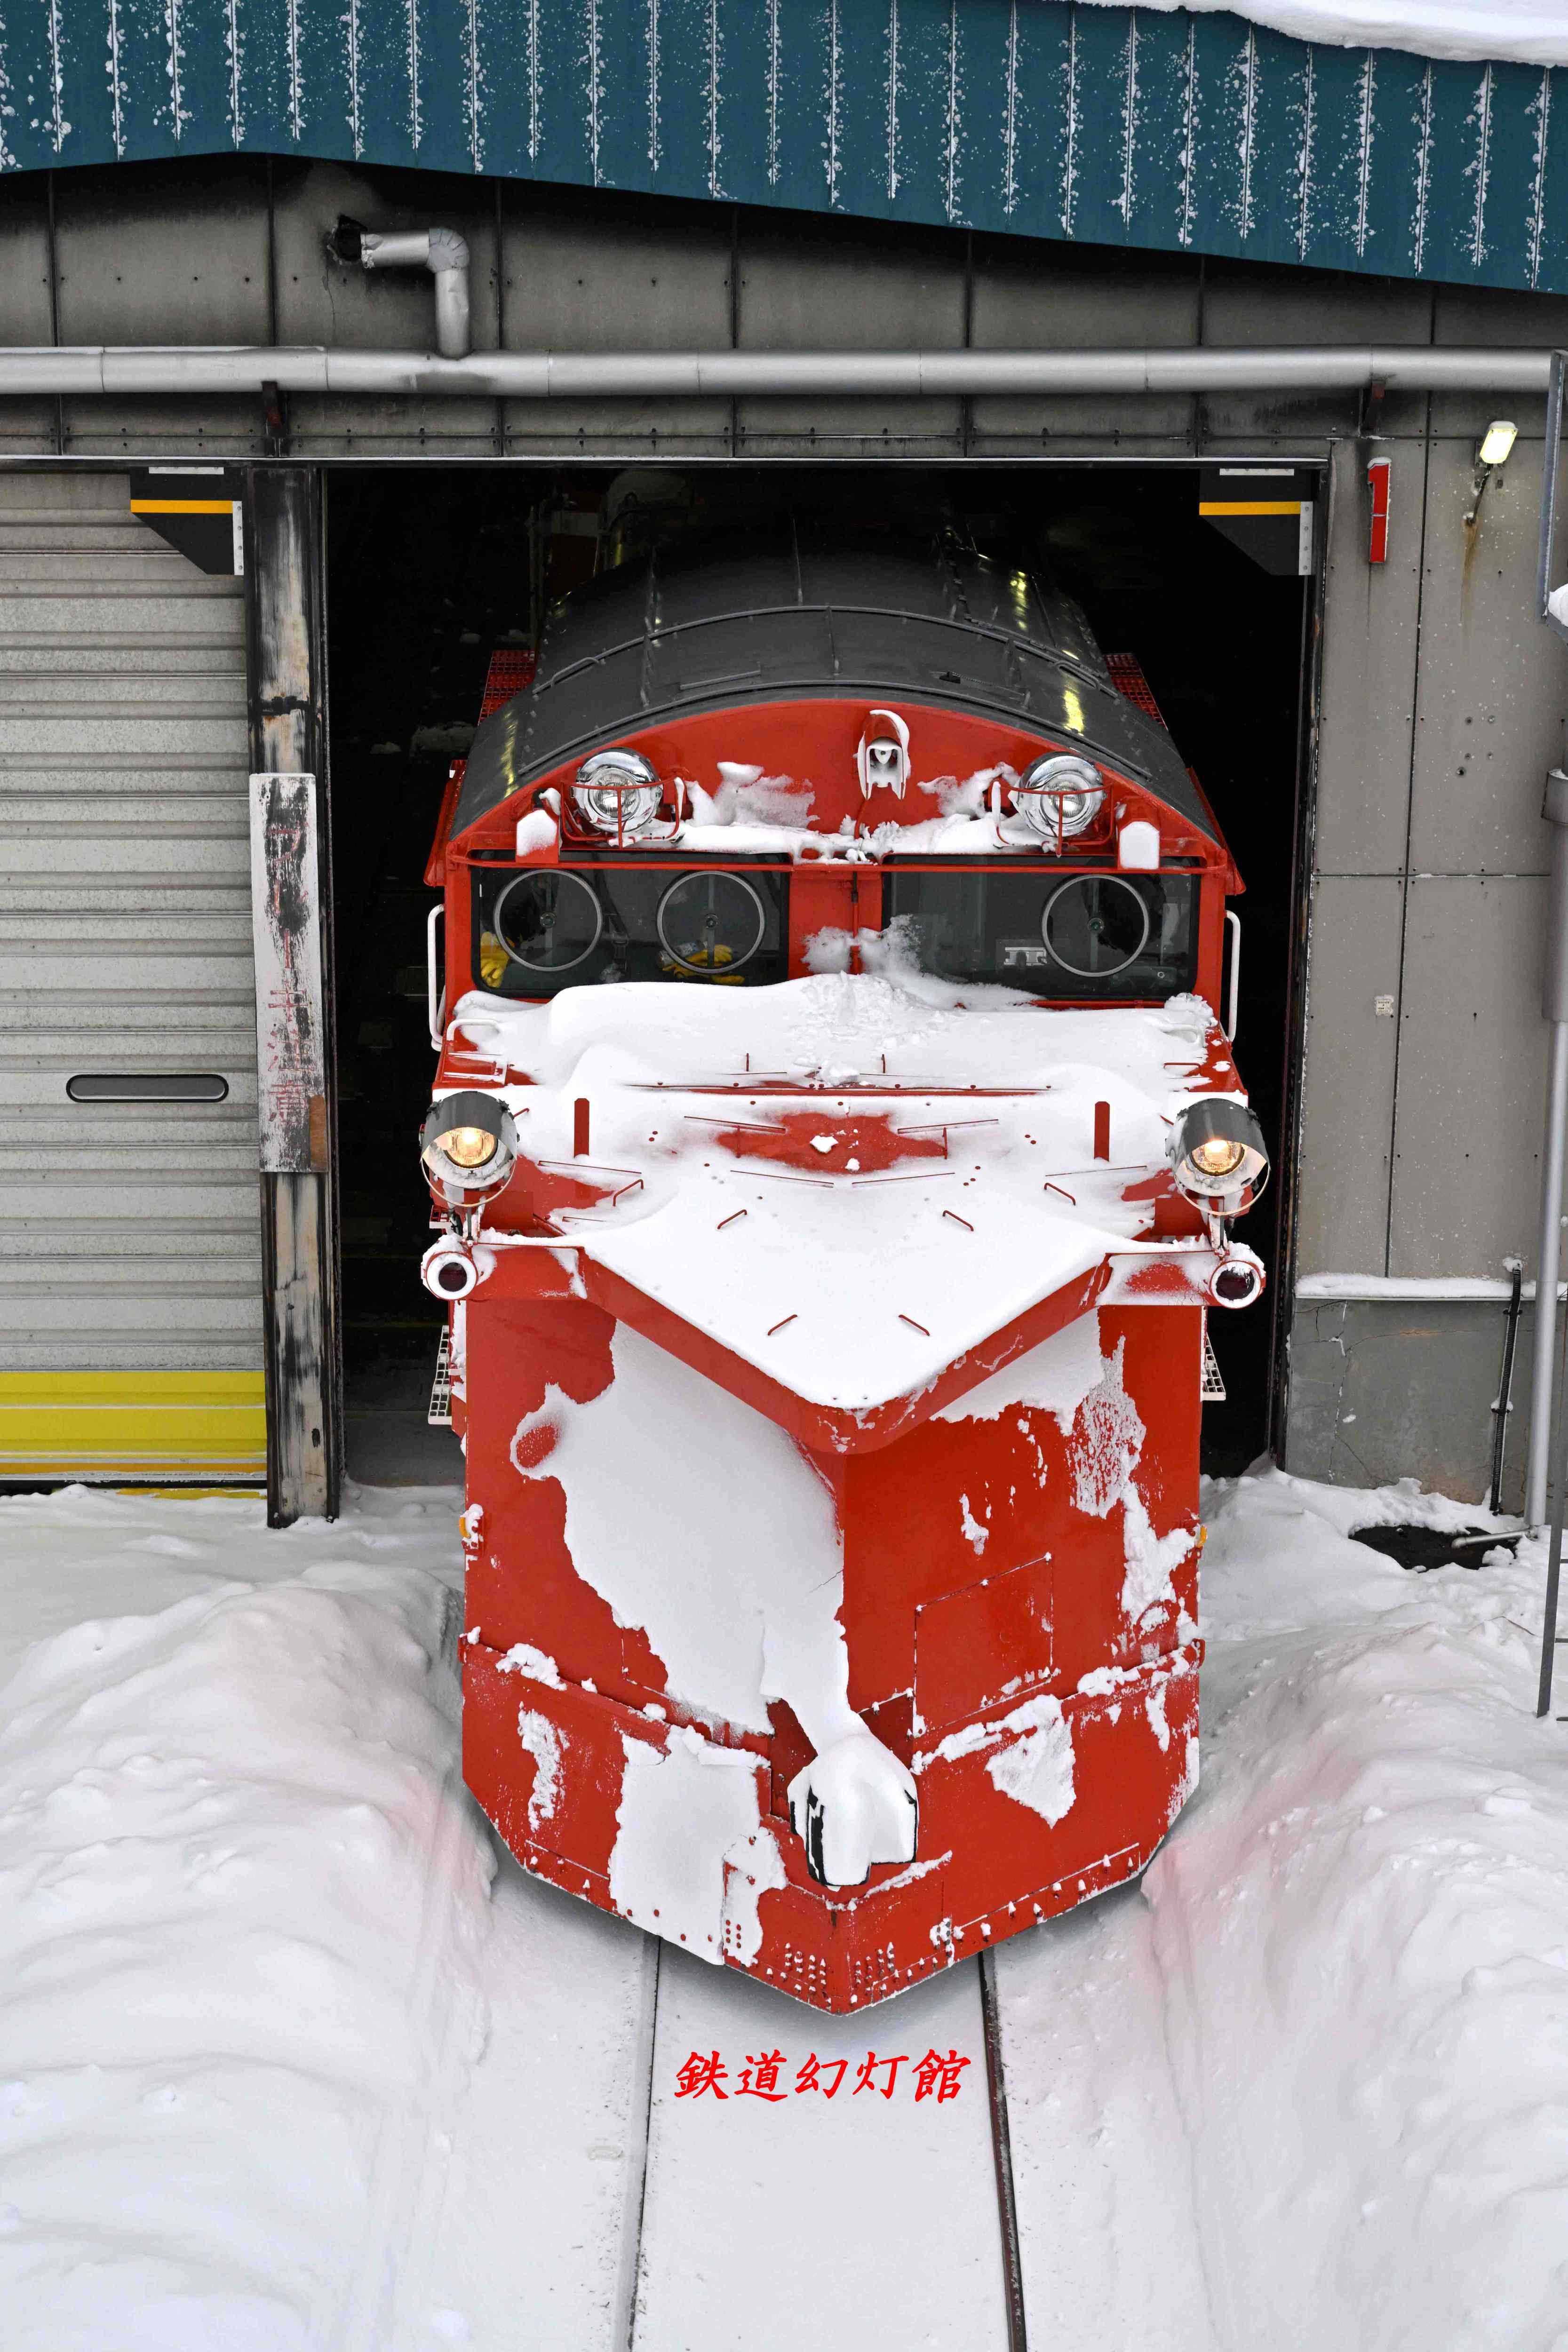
[381,1599,1225,2352]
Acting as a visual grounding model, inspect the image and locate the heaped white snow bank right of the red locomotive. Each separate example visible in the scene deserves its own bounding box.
[1145,1475,1568,2352]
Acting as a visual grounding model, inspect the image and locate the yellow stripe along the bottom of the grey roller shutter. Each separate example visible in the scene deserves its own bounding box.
[0,1371,266,1479]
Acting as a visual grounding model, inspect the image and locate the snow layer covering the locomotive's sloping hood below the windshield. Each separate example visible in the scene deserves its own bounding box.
[444,974,1239,1411]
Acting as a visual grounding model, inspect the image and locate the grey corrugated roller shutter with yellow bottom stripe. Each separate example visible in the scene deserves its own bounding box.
[0,473,266,1477]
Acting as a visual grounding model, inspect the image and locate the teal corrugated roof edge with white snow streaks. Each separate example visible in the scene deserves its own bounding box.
[0,0,1568,292]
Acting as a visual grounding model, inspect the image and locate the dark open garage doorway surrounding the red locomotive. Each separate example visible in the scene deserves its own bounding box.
[327,463,1309,1482]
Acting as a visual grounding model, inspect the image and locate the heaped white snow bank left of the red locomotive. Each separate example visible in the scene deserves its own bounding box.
[0,1489,491,2352]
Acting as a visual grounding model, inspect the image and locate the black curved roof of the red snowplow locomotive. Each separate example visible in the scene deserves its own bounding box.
[451,529,1215,840]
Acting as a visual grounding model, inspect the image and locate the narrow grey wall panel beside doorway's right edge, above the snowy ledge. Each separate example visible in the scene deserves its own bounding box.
[1297,875,1401,1275]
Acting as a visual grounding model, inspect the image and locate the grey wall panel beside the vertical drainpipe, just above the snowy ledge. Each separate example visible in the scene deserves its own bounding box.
[1392,875,1547,1275]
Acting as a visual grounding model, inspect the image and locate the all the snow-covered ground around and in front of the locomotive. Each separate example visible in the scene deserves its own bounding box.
[0,1475,1568,2352]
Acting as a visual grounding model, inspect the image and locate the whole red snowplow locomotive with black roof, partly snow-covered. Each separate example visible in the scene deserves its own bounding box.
[425,529,1267,2009]
